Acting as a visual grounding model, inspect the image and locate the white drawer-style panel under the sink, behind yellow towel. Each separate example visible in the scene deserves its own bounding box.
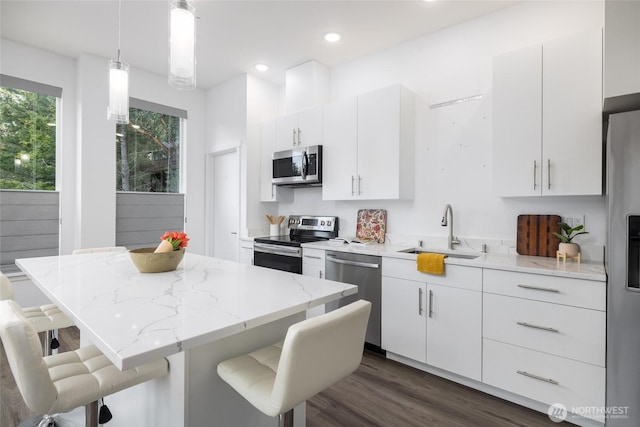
[382,257,482,291]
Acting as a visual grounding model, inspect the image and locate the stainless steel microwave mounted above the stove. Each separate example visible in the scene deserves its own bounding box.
[271,145,322,186]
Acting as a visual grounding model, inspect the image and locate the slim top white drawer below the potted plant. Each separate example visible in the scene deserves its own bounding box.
[483,269,607,311]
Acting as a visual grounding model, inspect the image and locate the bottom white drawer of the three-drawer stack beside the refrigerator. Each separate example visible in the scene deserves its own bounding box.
[482,339,605,421]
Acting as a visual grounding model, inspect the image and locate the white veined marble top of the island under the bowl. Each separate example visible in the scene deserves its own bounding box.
[16,252,357,369]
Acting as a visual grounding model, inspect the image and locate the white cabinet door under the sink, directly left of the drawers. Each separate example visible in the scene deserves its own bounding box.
[427,283,482,381]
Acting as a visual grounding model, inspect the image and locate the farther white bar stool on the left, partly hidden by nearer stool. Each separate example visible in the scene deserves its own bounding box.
[0,273,73,356]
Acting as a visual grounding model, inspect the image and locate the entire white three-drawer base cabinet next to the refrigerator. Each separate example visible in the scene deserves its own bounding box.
[482,269,606,421]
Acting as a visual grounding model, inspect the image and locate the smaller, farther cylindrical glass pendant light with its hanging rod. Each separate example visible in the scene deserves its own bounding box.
[108,0,129,124]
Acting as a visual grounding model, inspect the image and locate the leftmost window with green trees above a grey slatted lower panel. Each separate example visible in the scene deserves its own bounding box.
[0,74,62,274]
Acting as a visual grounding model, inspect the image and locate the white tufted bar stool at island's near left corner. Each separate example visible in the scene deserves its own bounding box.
[0,300,169,427]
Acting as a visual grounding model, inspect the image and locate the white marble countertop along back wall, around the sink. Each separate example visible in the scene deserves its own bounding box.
[302,241,607,282]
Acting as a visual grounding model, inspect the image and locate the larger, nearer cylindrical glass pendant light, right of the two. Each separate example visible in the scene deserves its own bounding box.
[169,0,196,90]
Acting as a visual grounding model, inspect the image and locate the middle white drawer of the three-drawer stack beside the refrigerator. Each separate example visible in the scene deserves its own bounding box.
[483,294,606,366]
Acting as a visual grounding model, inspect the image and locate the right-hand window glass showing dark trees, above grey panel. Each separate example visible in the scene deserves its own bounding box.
[116,98,186,193]
